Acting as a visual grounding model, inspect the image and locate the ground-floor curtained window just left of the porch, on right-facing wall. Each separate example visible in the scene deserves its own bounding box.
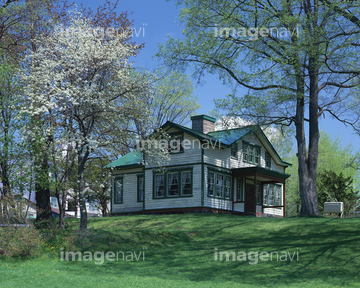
[208,171,232,199]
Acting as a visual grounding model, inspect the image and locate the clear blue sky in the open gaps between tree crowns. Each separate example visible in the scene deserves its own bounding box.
[75,0,360,150]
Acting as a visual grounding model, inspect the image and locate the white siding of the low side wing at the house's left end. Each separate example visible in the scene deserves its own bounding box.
[112,168,143,213]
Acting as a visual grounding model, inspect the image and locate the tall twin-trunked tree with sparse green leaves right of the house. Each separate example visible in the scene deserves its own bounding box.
[158,0,360,215]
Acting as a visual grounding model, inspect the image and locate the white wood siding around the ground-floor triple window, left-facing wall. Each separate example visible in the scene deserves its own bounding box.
[145,164,201,210]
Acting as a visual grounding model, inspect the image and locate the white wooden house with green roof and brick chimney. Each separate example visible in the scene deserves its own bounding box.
[107,115,291,217]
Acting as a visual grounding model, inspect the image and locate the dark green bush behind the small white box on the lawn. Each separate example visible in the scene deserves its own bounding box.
[317,170,359,215]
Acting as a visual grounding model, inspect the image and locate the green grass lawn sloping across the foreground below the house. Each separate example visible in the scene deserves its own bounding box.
[0,214,360,288]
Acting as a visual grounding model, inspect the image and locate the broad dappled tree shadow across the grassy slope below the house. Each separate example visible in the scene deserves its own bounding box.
[40,214,360,287]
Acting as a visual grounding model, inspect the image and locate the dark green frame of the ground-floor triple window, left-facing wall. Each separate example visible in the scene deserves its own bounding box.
[152,168,194,199]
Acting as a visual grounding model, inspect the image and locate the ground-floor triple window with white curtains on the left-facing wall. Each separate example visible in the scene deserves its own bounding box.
[154,170,192,198]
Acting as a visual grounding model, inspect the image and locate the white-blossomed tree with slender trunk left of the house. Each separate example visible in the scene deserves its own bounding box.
[21,12,152,229]
